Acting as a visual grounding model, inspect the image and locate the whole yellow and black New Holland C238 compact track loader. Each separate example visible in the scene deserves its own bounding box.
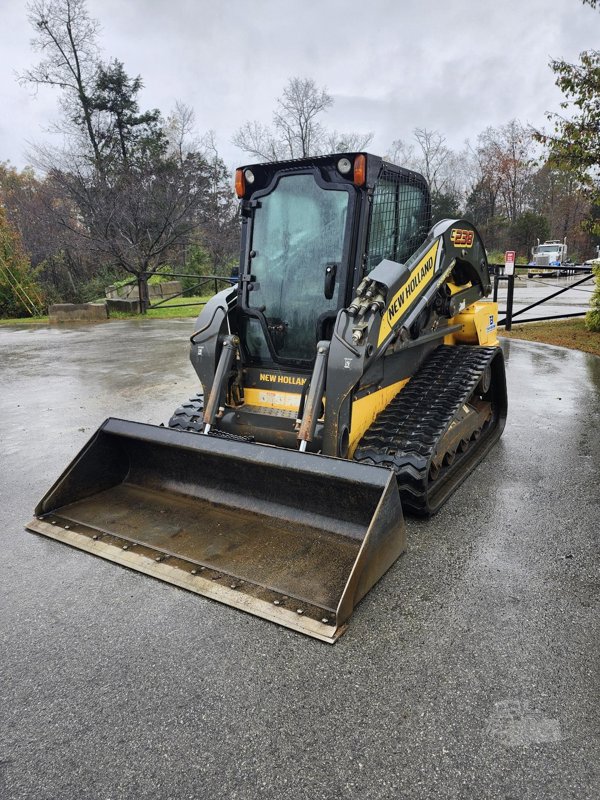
[28,153,506,642]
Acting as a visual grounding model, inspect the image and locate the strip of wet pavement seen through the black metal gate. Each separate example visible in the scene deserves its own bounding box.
[492,273,594,325]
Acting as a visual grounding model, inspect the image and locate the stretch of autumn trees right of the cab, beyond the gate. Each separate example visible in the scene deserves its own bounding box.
[392,119,600,260]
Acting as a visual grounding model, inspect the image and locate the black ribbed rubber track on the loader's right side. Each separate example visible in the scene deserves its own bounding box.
[354,345,502,515]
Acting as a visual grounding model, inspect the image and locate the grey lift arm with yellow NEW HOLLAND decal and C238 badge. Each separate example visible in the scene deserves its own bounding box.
[316,220,491,456]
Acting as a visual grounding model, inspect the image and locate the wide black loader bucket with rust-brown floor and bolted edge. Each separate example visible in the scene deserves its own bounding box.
[27,419,405,642]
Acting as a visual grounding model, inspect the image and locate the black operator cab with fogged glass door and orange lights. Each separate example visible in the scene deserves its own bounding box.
[236,153,431,370]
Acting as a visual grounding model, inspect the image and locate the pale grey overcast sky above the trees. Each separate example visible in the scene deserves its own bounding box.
[0,0,600,173]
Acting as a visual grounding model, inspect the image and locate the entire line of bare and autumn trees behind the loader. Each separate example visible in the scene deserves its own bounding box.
[0,0,600,316]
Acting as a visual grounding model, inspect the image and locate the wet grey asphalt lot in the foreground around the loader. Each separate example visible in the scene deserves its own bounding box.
[0,320,600,800]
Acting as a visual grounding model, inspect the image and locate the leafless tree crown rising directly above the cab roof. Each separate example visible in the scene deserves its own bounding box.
[232,77,373,161]
